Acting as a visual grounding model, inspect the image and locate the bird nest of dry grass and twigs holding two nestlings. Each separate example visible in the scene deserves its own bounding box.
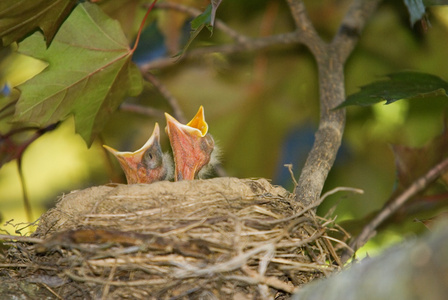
[0,178,350,299]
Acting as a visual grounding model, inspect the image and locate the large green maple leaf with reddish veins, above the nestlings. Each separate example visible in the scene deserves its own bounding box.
[14,3,142,145]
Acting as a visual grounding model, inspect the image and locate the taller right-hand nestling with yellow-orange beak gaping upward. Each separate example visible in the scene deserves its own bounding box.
[165,106,214,181]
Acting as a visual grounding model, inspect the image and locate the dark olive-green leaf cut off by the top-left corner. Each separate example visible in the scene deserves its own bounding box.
[0,0,77,46]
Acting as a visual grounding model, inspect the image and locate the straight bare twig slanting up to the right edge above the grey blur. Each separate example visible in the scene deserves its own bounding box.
[343,158,448,261]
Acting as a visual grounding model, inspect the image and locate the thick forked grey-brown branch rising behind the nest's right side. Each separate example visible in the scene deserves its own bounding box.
[288,0,379,205]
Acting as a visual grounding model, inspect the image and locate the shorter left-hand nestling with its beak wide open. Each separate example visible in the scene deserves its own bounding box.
[103,123,173,184]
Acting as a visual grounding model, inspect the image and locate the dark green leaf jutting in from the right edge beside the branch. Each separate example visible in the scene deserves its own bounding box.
[336,72,448,108]
